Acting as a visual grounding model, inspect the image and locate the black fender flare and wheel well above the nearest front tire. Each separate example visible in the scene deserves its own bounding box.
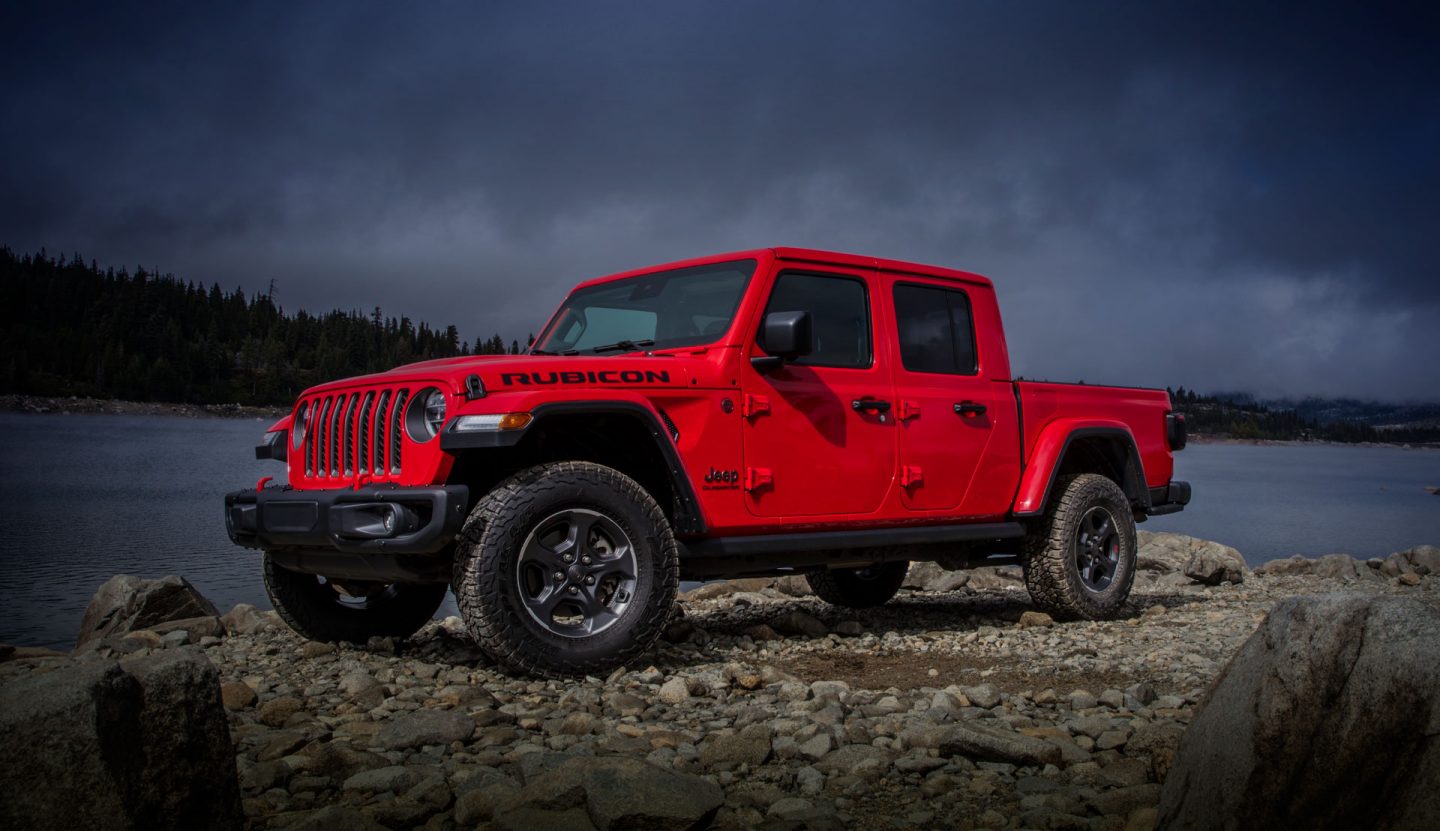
[449,412,698,531]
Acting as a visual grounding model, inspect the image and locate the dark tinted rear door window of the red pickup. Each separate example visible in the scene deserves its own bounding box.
[896,282,976,374]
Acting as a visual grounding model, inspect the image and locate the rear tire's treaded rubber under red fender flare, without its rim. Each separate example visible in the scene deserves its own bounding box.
[1024,474,1136,619]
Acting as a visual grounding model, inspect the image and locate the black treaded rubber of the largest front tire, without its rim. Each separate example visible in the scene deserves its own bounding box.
[452,461,680,677]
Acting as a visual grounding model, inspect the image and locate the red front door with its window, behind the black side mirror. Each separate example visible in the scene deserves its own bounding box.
[740,264,896,517]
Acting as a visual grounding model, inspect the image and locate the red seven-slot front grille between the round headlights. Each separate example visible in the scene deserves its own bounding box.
[301,387,410,484]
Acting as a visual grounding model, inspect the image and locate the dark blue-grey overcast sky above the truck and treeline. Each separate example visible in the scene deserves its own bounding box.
[0,0,1440,400]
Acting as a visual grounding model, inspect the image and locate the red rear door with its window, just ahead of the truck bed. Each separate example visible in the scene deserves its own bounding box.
[884,275,1007,514]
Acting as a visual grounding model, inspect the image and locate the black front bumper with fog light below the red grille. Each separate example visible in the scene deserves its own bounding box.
[225,485,469,554]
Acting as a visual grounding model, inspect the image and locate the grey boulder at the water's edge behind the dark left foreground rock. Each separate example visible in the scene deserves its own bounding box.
[75,575,220,648]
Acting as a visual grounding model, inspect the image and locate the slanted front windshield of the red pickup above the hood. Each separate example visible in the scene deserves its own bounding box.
[531,259,756,354]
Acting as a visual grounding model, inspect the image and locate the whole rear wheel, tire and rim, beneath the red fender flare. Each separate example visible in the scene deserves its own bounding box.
[1025,474,1136,619]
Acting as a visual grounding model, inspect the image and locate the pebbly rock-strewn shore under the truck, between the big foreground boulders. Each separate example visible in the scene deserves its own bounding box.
[0,534,1440,831]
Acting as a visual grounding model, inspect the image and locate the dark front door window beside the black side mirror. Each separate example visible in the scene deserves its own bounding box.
[760,272,870,369]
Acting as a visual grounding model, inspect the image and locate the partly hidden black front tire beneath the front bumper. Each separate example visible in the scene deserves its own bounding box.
[265,553,449,644]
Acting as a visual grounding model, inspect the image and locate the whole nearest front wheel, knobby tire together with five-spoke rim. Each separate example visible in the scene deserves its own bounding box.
[454,462,680,675]
